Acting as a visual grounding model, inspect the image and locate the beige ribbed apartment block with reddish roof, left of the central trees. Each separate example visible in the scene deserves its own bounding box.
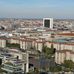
[20,38,44,51]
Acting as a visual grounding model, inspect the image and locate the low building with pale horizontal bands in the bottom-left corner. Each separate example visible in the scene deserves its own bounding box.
[2,59,23,74]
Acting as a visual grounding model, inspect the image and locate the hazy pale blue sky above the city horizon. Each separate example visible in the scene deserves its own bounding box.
[0,0,74,18]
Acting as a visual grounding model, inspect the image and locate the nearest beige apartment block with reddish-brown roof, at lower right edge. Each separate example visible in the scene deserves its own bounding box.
[55,50,74,64]
